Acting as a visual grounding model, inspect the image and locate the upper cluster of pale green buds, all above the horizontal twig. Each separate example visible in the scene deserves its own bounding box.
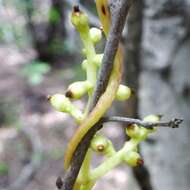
[50,6,131,123]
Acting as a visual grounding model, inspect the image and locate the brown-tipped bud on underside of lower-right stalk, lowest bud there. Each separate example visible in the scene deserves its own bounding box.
[124,151,143,166]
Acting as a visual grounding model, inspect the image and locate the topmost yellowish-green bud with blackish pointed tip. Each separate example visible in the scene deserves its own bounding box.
[71,6,89,33]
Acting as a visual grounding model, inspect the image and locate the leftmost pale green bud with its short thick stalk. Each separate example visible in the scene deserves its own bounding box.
[49,94,84,123]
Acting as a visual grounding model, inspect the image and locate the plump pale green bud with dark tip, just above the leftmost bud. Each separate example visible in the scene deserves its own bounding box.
[65,81,92,99]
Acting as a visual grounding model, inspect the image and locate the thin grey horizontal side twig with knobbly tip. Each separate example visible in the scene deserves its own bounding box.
[102,116,183,129]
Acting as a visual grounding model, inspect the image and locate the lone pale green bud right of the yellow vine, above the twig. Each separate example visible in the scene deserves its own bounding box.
[116,84,131,101]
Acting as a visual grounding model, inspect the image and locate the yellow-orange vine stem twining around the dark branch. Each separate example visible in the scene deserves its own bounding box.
[64,0,123,169]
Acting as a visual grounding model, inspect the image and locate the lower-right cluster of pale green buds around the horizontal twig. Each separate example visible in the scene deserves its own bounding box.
[88,115,160,168]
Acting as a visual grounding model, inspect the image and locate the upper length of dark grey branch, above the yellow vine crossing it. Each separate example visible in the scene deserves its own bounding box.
[92,0,133,107]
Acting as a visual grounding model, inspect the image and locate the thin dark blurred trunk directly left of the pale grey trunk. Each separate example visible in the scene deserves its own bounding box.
[125,0,152,190]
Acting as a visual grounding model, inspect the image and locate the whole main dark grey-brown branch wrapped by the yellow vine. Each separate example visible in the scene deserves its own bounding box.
[59,0,132,190]
